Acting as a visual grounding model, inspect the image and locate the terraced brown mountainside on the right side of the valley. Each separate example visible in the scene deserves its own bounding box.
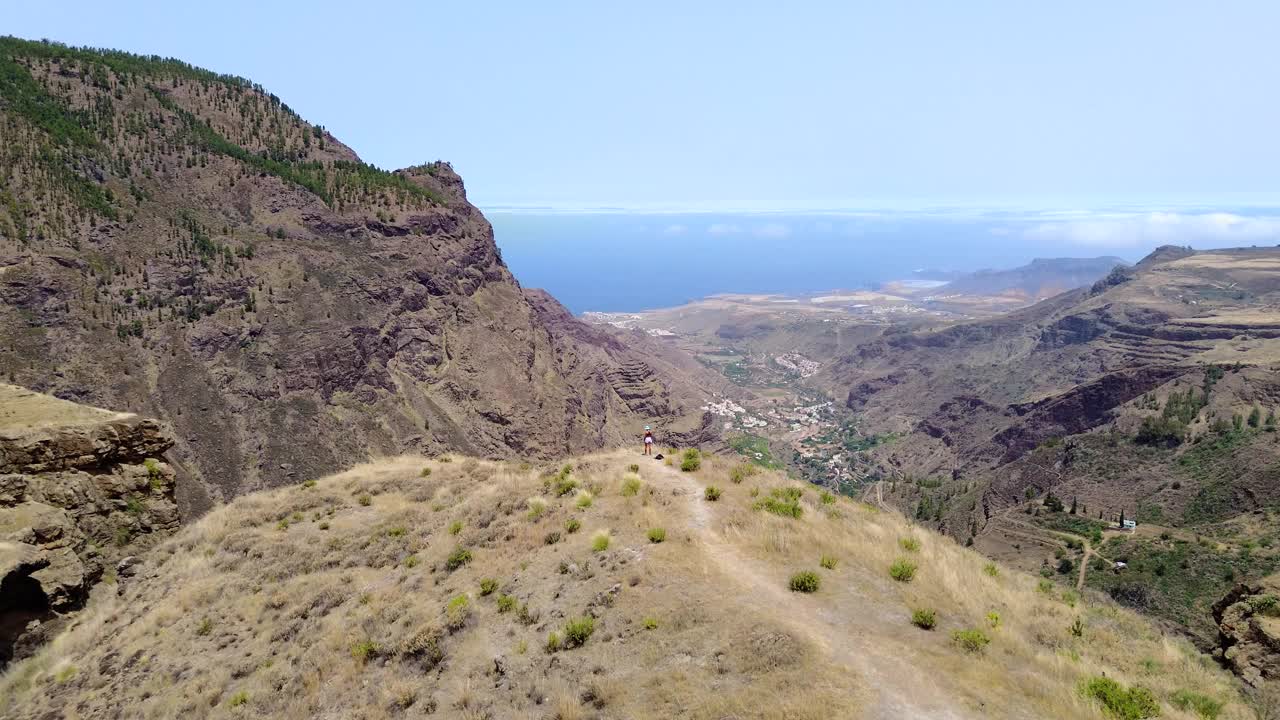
[820,247,1280,648]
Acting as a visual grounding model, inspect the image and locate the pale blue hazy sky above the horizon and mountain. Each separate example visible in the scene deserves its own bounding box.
[0,0,1280,209]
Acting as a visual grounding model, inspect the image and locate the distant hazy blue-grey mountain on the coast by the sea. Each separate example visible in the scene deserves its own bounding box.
[933,256,1128,300]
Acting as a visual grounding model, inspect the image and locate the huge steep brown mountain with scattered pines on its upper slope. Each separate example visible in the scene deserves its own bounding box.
[0,37,708,516]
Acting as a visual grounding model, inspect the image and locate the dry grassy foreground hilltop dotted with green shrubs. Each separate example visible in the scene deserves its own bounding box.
[0,451,1252,720]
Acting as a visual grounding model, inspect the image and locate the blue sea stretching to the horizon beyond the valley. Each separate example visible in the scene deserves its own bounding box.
[485,209,1280,314]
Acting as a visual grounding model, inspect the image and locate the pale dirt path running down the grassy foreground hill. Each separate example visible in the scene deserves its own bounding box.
[646,453,968,720]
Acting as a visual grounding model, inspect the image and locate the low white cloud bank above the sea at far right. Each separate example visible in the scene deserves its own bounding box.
[1027,213,1280,247]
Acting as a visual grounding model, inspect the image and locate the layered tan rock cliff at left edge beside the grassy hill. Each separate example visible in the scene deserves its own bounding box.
[0,386,178,665]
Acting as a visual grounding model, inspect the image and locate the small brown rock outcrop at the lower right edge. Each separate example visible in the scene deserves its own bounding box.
[1213,575,1280,687]
